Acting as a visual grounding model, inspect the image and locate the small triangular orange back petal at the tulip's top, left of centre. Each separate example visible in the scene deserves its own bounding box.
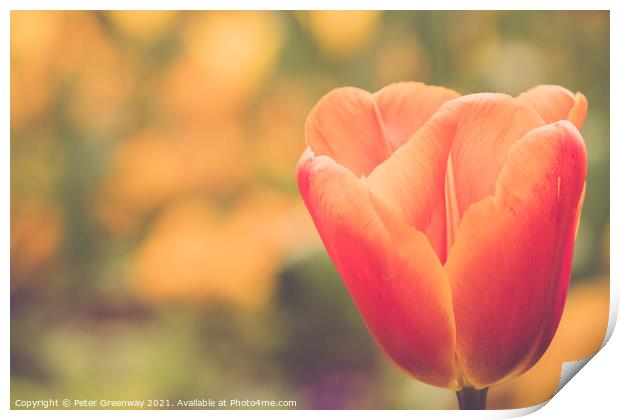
[375,82,460,150]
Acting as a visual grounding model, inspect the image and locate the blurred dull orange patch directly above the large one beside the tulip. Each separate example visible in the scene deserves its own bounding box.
[94,122,251,235]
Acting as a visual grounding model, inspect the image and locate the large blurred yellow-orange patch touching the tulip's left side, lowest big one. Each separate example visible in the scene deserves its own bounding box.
[129,193,309,310]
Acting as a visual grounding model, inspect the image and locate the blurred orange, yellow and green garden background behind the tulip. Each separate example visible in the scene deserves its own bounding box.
[11,11,609,409]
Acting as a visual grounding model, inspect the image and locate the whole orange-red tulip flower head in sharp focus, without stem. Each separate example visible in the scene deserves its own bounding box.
[297,82,587,406]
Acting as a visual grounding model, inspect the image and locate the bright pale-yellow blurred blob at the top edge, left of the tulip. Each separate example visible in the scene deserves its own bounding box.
[162,12,282,122]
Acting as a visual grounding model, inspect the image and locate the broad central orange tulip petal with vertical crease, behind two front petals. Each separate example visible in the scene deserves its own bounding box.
[368,93,544,262]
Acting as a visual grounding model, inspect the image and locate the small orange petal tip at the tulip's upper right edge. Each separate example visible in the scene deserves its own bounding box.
[518,85,588,128]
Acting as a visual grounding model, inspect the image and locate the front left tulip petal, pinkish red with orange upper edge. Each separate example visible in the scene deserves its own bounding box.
[297,149,457,388]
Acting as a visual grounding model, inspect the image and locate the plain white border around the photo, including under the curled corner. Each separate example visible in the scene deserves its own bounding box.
[0,0,620,419]
